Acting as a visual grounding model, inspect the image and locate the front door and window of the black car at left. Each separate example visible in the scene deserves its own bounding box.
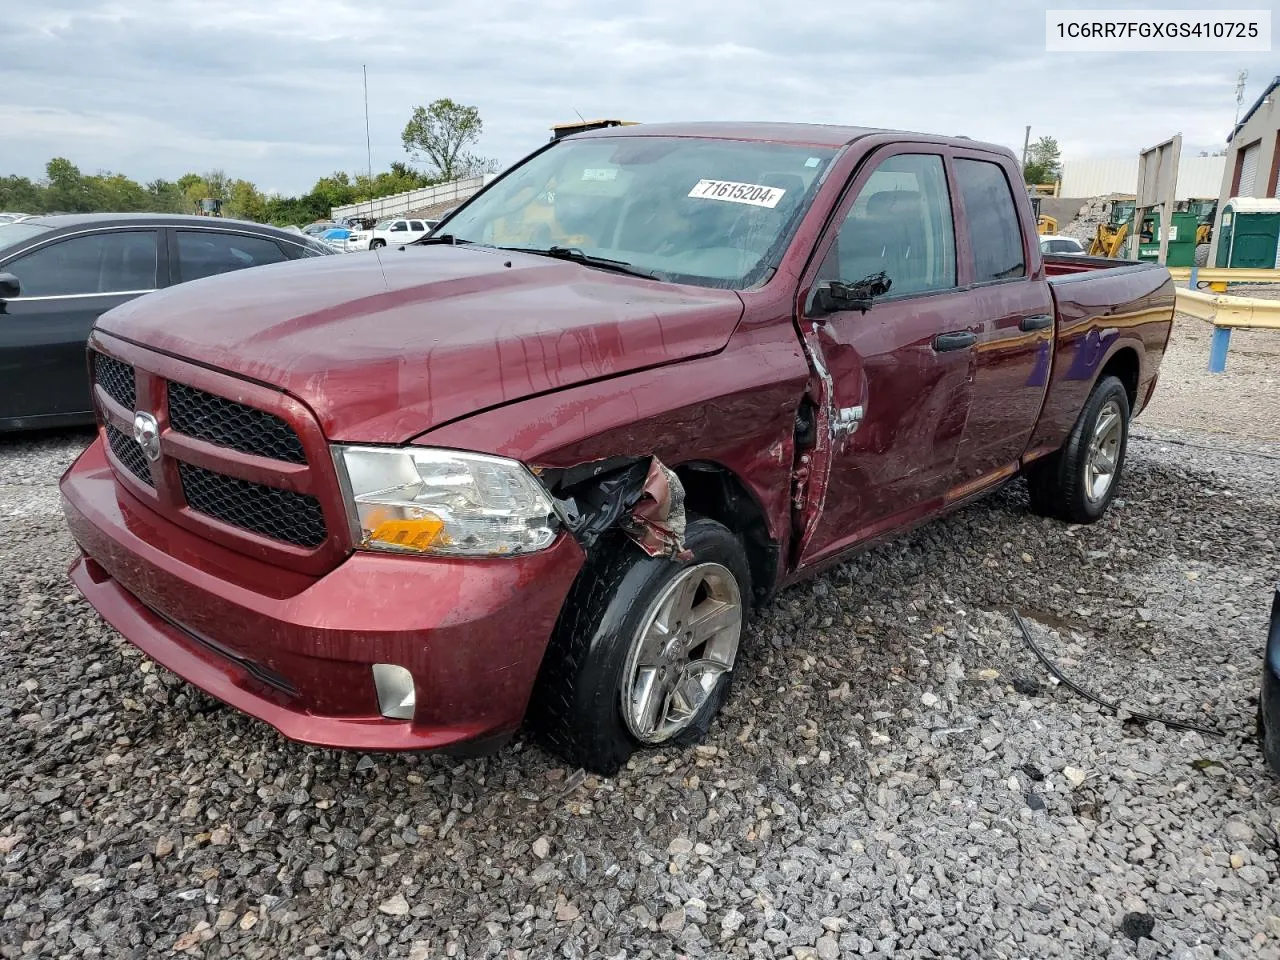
[0,229,166,426]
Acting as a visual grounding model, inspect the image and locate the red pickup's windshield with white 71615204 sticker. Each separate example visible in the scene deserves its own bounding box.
[440,137,835,289]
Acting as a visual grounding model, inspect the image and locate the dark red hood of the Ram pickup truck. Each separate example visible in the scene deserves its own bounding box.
[99,246,742,443]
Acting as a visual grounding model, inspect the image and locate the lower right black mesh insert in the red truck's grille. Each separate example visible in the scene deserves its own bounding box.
[178,462,328,547]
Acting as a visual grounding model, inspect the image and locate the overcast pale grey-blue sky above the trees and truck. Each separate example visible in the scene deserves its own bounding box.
[0,0,1280,193]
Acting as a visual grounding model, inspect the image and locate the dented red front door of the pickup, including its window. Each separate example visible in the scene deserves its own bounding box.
[799,152,980,566]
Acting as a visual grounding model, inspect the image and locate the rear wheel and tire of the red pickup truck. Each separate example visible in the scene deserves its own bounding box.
[1027,376,1129,524]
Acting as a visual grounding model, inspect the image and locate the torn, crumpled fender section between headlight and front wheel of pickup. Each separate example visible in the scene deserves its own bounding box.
[534,456,690,559]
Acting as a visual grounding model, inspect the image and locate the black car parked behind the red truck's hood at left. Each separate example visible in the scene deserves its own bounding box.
[0,214,333,430]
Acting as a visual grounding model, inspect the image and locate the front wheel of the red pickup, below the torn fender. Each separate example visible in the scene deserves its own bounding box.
[529,518,751,776]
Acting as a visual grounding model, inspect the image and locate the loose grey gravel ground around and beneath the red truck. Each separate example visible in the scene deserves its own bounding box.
[0,421,1280,960]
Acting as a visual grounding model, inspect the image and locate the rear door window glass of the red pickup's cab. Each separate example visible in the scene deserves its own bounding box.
[955,157,1027,284]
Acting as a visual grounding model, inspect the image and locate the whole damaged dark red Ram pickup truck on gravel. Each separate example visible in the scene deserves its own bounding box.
[61,123,1174,773]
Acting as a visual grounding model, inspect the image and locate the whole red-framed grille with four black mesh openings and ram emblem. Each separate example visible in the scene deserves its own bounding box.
[91,339,346,563]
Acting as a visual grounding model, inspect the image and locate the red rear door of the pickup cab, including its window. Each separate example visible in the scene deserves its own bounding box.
[951,158,1053,497]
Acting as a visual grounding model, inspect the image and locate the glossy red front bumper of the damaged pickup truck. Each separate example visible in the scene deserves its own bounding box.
[61,440,584,750]
